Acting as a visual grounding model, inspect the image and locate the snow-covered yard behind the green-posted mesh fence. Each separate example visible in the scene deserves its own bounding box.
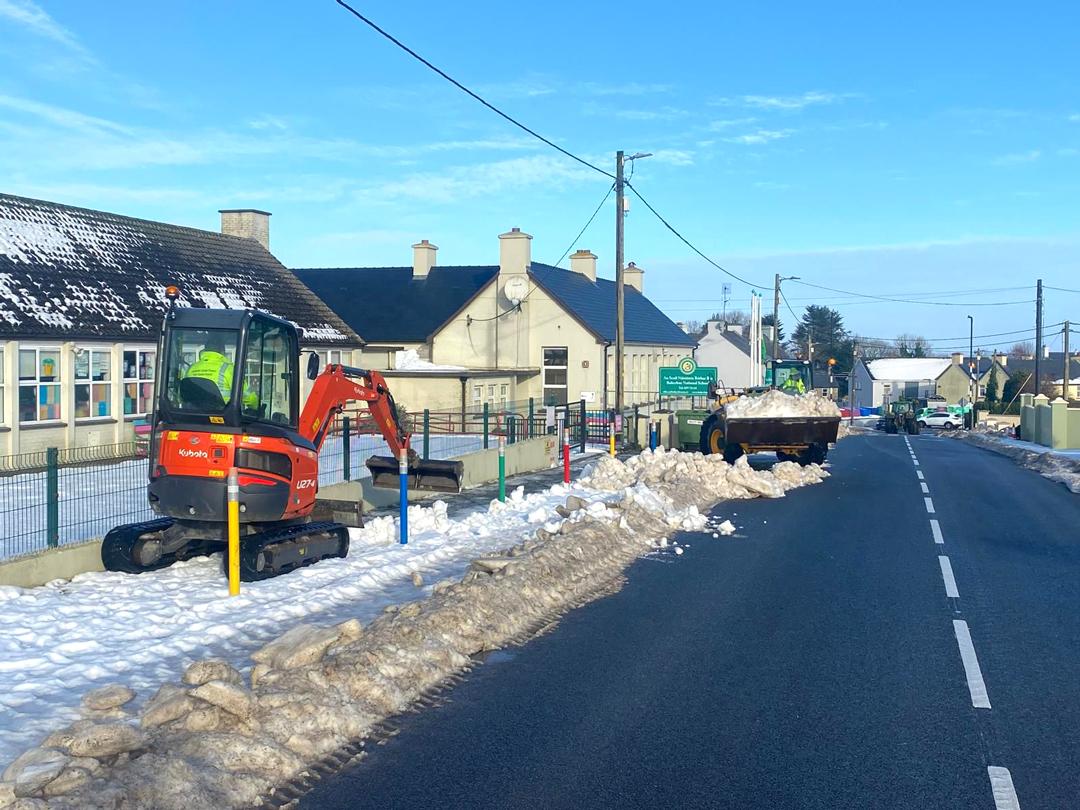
[0,433,484,559]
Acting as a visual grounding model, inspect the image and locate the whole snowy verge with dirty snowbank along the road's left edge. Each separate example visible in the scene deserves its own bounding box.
[0,450,827,810]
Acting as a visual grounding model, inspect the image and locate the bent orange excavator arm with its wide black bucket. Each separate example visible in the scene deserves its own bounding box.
[300,364,462,492]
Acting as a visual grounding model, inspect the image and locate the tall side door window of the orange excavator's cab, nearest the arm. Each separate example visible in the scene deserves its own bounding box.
[240,319,298,424]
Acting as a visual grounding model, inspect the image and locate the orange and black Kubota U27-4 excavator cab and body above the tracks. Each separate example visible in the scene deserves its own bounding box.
[149,309,318,523]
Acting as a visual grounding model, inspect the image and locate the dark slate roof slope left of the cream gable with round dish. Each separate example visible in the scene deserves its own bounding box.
[294,266,499,343]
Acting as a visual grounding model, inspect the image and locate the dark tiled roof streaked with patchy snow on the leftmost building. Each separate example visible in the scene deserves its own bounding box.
[0,194,361,346]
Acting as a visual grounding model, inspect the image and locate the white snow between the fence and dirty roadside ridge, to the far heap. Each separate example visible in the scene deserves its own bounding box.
[0,450,825,777]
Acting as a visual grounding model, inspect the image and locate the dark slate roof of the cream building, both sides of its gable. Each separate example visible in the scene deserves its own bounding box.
[294,262,696,347]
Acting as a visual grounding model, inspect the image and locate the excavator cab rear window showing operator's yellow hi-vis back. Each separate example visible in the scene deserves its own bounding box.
[164,328,239,415]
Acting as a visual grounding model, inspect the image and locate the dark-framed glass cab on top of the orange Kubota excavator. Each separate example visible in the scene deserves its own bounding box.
[156,309,299,435]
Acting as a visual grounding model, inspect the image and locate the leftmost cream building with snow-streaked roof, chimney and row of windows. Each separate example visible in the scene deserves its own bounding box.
[0,194,362,455]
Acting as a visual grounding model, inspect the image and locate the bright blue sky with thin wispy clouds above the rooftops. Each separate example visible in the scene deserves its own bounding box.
[0,0,1080,349]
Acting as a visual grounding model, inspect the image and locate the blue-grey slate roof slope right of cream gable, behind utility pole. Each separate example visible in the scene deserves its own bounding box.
[529,262,696,347]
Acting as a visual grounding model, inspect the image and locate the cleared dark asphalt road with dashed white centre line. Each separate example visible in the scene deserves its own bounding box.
[301,435,1080,810]
